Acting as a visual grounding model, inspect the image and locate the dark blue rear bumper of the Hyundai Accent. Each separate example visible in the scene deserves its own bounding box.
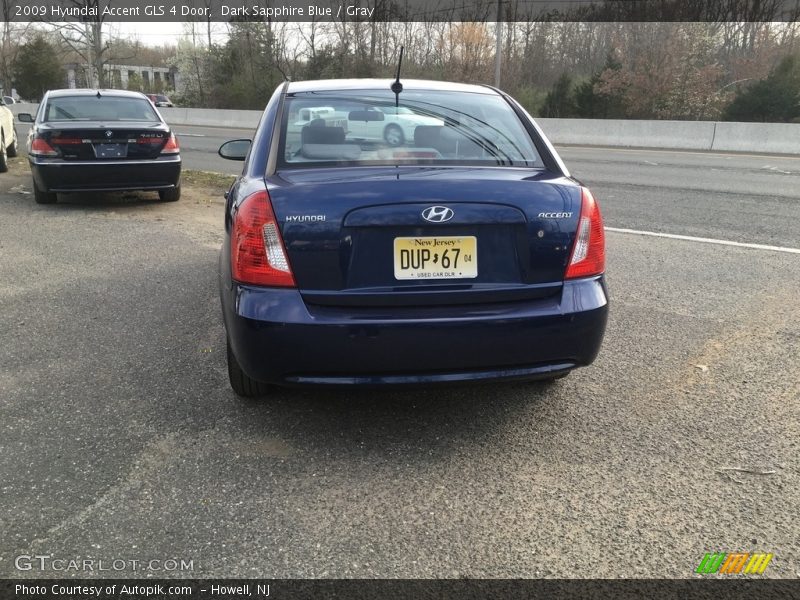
[221,277,608,385]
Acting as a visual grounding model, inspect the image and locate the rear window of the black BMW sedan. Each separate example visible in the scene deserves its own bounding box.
[44,96,159,121]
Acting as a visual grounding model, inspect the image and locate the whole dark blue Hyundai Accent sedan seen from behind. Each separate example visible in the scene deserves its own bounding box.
[220,80,608,396]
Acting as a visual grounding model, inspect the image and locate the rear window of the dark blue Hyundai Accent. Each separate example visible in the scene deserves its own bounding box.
[280,89,543,167]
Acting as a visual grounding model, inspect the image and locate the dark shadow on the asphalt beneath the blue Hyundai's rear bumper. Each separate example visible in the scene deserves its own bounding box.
[206,382,568,462]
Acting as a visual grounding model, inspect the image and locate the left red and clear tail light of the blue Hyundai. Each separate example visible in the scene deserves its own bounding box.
[231,190,295,287]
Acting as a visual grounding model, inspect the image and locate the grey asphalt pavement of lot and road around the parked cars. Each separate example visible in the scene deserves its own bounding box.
[0,138,800,578]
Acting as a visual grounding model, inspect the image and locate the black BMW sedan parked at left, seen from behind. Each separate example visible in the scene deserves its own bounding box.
[18,90,181,204]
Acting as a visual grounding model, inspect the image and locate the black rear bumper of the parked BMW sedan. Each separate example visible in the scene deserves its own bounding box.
[28,156,181,192]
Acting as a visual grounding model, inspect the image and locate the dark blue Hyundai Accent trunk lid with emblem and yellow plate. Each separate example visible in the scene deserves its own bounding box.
[268,167,581,306]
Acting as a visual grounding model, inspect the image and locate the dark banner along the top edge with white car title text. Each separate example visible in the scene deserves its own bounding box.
[4,0,800,22]
